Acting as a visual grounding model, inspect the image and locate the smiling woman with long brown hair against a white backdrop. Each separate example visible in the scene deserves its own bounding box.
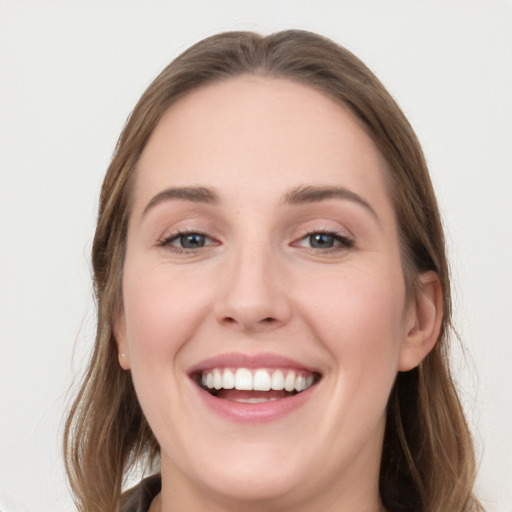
[65,31,481,512]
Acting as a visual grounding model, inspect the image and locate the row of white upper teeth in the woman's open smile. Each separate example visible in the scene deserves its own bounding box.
[201,368,314,392]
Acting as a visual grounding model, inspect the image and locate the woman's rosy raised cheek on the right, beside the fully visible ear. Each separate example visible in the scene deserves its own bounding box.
[302,266,405,376]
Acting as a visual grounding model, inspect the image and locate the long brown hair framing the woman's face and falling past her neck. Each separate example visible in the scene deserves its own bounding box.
[64,30,482,512]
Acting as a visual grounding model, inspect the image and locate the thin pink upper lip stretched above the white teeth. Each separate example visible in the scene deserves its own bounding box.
[188,352,320,375]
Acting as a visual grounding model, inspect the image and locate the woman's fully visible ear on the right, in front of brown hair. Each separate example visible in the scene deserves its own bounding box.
[399,271,443,372]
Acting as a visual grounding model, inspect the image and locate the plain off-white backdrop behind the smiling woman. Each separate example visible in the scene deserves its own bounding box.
[0,0,512,512]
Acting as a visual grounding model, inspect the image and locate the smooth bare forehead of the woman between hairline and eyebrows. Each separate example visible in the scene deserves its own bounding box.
[135,75,394,214]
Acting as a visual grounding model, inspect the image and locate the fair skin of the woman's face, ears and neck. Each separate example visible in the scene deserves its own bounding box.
[116,76,441,512]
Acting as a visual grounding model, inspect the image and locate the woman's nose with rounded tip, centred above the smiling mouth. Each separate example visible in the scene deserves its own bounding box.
[215,243,292,333]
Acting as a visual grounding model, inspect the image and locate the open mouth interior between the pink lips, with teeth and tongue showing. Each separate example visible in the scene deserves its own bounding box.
[193,368,321,404]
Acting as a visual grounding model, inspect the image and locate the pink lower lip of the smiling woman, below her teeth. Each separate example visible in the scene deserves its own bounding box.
[194,383,318,423]
